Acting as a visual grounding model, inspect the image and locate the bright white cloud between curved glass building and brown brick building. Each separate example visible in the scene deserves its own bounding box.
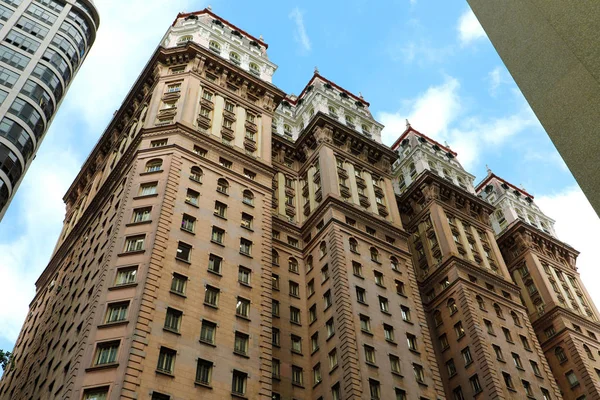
[0,0,197,350]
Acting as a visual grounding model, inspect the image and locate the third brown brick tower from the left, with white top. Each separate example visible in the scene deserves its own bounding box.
[393,123,560,399]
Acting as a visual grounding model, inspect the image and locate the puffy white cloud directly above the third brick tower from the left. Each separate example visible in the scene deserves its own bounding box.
[377,77,539,169]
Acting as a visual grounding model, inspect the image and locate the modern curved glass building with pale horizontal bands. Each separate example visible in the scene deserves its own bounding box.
[0,0,100,220]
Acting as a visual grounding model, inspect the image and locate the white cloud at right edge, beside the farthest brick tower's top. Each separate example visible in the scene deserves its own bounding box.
[535,186,600,310]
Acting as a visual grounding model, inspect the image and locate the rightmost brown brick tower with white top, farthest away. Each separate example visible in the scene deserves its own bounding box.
[477,171,600,399]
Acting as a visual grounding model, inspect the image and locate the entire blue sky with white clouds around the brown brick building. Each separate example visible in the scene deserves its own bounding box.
[0,0,600,356]
